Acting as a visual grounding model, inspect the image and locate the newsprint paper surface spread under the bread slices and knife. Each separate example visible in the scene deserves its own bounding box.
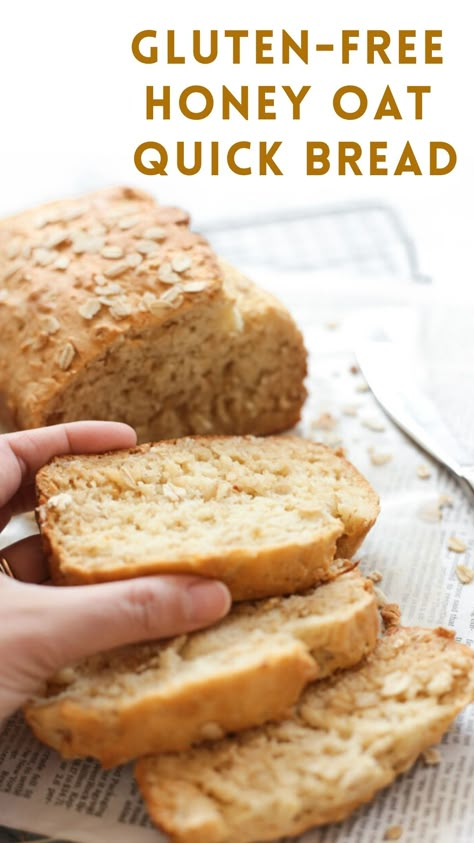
[0,271,474,843]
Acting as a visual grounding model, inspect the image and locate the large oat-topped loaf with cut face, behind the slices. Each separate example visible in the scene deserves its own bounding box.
[0,188,306,441]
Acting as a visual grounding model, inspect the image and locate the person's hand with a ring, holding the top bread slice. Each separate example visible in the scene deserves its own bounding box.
[0,422,230,723]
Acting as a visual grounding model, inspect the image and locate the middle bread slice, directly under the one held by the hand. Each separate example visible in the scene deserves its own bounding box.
[25,566,378,767]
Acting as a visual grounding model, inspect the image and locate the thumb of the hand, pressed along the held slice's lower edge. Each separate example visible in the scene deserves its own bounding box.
[2,576,230,690]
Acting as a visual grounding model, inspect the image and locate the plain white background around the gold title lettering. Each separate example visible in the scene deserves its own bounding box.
[0,0,473,283]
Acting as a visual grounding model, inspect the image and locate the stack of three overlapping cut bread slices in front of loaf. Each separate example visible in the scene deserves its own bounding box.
[25,436,474,843]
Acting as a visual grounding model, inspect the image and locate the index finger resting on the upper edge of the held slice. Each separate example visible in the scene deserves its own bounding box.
[0,421,137,512]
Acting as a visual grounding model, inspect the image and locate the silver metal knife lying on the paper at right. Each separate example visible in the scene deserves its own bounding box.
[354,307,474,503]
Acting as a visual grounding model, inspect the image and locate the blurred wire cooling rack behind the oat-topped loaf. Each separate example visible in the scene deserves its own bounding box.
[0,196,428,843]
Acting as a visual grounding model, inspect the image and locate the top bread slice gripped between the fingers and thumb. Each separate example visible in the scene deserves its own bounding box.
[36,437,378,600]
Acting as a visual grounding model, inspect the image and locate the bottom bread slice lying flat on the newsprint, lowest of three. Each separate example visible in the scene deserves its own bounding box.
[136,629,474,843]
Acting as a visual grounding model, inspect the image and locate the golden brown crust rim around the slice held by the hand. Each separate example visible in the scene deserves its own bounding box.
[36,436,378,600]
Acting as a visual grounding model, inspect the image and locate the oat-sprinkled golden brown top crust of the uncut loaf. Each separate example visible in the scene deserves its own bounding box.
[0,188,222,427]
